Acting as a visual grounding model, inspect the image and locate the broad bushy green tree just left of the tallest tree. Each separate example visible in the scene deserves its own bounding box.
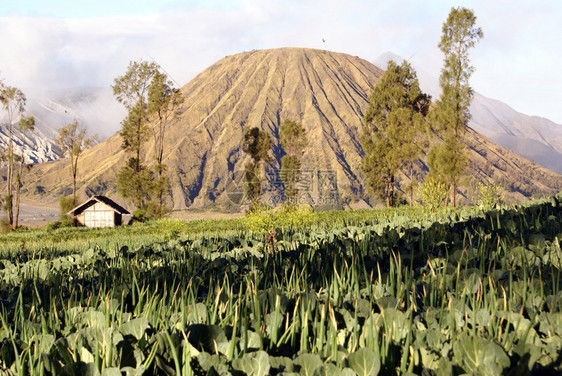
[361,61,431,207]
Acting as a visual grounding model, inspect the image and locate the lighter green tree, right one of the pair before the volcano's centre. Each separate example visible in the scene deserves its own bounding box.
[279,119,308,202]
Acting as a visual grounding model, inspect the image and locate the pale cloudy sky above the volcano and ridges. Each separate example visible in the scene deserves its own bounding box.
[0,0,562,123]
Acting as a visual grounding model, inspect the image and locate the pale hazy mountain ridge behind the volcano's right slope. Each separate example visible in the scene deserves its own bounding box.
[374,52,562,174]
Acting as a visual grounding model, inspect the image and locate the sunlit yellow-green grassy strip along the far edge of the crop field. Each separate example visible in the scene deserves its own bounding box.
[0,207,480,255]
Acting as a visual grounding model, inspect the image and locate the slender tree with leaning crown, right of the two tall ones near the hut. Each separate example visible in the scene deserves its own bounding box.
[147,71,184,216]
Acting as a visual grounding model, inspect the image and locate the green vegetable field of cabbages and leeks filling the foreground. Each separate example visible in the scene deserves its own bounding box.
[0,196,562,376]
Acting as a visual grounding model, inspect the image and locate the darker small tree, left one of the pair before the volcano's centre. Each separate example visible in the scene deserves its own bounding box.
[242,127,272,203]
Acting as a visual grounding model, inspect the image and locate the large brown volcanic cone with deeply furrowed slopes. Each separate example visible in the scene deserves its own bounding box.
[20,48,562,209]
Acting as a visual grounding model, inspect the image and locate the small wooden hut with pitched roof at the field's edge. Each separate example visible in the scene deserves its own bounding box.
[68,196,130,227]
